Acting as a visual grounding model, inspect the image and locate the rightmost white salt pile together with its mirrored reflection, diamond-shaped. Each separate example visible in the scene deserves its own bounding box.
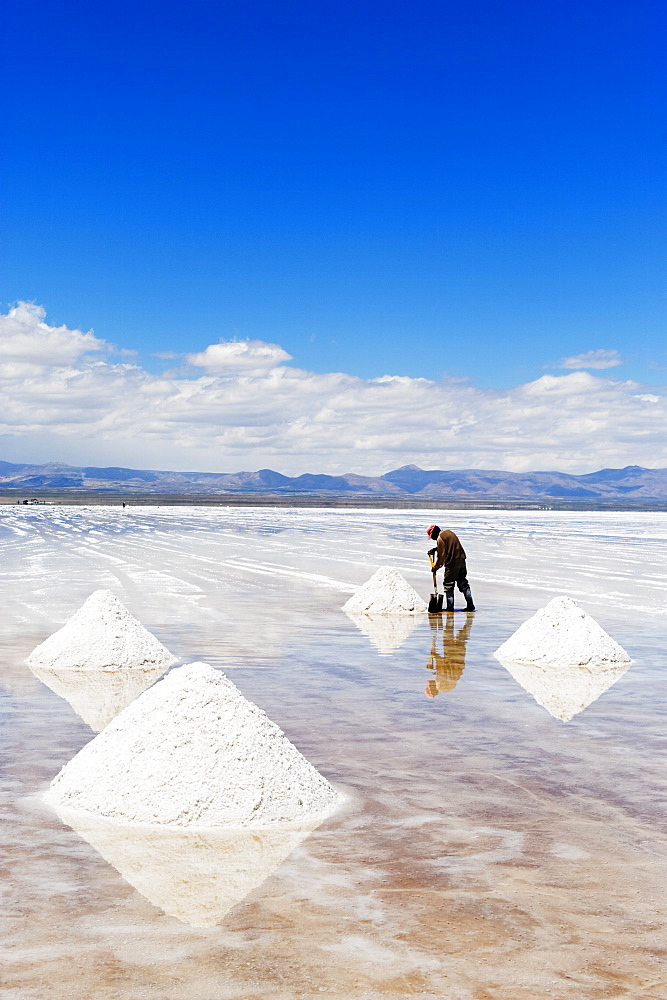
[495,597,632,722]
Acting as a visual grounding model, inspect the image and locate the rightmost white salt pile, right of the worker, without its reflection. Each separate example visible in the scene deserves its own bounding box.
[495,597,631,668]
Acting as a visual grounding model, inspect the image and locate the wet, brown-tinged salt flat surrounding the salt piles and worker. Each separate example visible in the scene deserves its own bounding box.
[0,507,667,1000]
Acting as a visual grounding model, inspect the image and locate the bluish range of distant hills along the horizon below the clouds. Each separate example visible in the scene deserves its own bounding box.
[0,462,667,501]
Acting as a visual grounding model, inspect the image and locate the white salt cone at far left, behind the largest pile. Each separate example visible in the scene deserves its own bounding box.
[27,590,178,670]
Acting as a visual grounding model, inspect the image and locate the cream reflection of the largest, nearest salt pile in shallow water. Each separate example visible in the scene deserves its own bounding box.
[52,809,317,927]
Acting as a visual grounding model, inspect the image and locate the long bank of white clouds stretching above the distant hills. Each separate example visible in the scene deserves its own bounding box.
[0,306,667,475]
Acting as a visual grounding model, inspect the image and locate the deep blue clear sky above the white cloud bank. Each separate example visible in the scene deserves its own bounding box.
[0,0,667,472]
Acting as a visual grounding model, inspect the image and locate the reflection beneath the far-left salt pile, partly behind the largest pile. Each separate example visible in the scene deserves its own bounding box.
[30,666,167,733]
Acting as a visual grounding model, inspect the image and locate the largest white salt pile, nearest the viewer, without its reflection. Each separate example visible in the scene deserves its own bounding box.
[46,663,340,829]
